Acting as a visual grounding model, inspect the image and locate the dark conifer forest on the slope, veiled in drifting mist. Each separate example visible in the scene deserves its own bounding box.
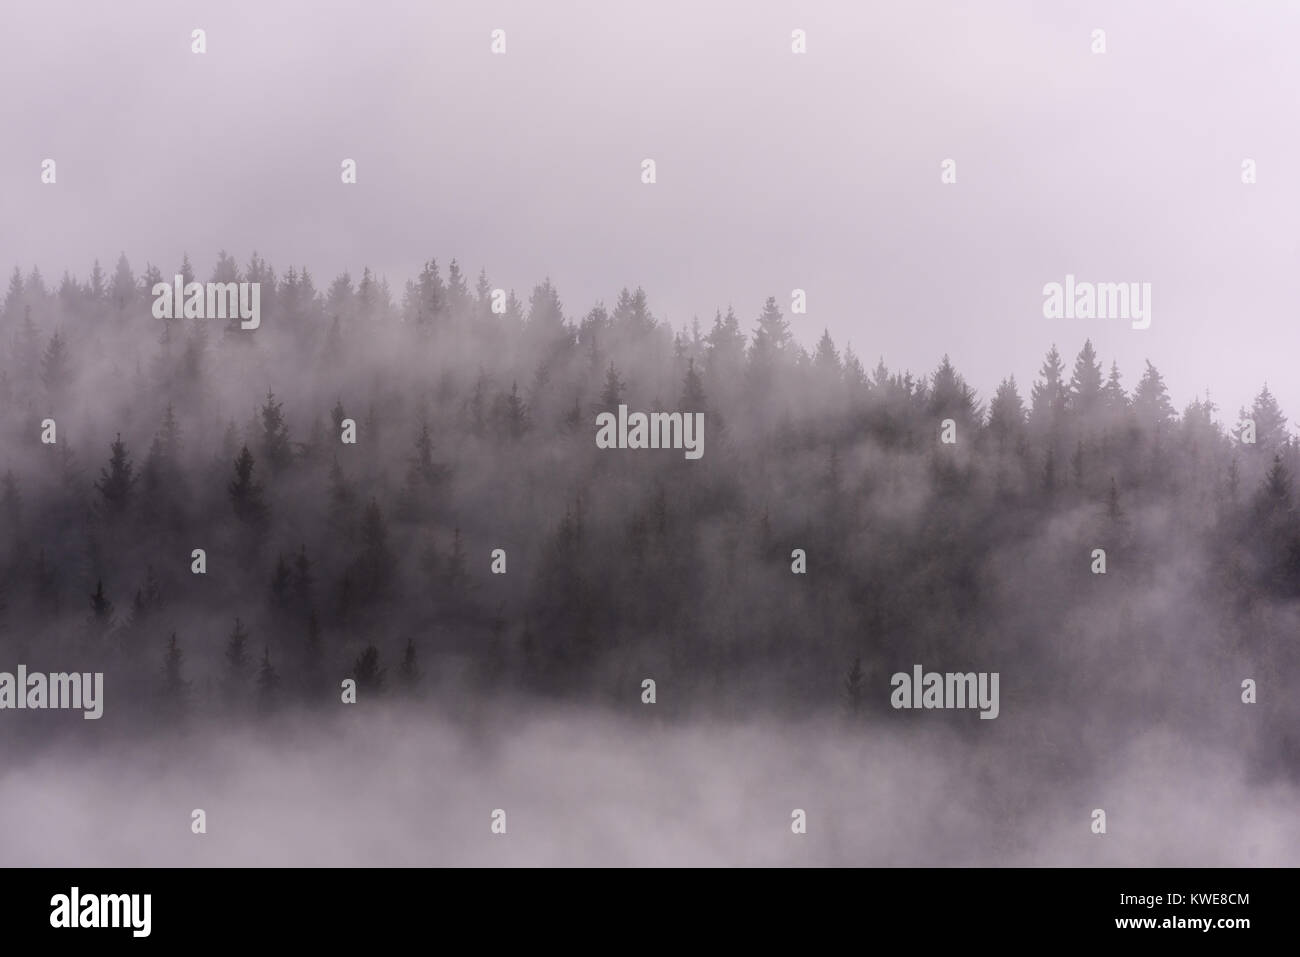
[0,252,1300,790]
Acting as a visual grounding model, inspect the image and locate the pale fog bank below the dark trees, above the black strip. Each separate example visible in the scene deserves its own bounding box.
[0,709,1300,866]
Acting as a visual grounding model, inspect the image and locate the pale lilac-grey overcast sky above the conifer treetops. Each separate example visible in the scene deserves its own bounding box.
[0,0,1300,419]
